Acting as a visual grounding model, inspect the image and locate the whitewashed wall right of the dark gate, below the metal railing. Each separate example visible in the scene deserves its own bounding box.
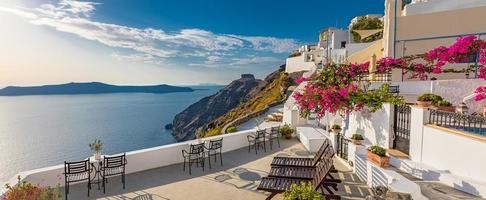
[406,106,486,197]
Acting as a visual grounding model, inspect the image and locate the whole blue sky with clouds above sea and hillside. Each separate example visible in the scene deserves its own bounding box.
[0,0,384,87]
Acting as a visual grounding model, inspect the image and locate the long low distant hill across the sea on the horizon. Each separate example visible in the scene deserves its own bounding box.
[0,82,194,96]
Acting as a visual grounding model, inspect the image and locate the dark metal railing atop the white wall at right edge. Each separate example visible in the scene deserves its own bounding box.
[429,109,486,136]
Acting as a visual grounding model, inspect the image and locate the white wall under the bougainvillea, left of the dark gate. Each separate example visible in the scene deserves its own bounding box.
[344,103,393,148]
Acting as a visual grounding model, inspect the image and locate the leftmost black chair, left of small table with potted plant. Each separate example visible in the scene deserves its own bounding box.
[64,158,92,200]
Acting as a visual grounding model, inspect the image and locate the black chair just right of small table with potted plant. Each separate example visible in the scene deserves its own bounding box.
[101,154,127,193]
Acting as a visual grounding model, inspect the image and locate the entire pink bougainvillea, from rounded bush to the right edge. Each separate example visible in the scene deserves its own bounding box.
[293,36,486,118]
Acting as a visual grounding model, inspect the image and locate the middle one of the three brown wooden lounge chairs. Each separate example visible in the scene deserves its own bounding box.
[268,144,341,182]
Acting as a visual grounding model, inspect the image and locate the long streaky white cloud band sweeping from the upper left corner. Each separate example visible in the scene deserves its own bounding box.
[0,0,297,65]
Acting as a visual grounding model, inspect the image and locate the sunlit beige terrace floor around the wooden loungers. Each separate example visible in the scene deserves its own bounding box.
[63,139,371,200]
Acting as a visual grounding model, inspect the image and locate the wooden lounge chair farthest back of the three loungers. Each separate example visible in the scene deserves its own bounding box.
[271,139,332,168]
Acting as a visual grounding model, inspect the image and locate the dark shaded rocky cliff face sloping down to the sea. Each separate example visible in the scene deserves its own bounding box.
[172,74,264,141]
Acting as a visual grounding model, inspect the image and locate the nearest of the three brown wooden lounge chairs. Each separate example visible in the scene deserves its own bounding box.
[257,156,341,199]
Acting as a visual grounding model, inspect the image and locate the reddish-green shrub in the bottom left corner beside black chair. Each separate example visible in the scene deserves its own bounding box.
[2,176,61,200]
